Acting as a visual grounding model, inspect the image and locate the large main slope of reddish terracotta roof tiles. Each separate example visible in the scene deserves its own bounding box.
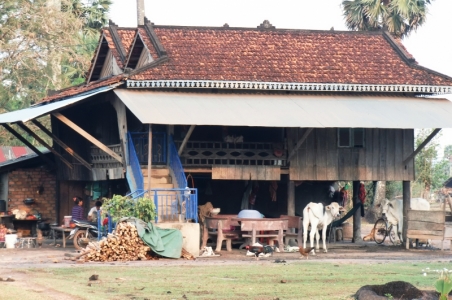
[126,26,452,86]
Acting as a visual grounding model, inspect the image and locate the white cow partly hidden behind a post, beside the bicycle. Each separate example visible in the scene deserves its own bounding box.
[377,198,430,243]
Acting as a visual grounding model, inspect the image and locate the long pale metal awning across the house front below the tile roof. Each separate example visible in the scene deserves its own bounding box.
[114,89,452,128]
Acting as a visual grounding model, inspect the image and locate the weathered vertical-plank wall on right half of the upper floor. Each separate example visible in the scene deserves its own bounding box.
[287,128,414,181]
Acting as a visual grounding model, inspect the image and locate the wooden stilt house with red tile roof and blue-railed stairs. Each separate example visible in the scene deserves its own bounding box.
[0,20,452,250]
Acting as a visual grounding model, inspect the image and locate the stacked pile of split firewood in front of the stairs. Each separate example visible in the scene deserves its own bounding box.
[77,222,158,262]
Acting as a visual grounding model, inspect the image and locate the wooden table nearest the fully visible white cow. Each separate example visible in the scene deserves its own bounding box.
[231,218,289,252]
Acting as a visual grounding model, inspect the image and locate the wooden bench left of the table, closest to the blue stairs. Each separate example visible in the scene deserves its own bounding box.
[201,215,239,252]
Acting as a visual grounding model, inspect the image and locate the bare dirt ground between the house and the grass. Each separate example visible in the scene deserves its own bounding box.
[0,224,452,300]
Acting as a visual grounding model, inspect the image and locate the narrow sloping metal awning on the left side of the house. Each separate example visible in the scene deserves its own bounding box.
[0,85,117,124]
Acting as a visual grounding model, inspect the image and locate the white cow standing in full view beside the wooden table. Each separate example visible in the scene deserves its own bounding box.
[303,202,344,252]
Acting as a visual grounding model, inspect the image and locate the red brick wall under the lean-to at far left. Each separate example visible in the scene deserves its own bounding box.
[8,168,56,223]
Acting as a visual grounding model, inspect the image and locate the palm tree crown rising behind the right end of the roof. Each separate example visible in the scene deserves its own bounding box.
[342,0,433,38]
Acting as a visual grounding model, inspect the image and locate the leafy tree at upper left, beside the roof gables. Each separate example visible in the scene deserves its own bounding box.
[0,0,111,145]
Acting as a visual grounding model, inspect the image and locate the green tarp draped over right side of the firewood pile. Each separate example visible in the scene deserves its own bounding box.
[120,218,183,258]
